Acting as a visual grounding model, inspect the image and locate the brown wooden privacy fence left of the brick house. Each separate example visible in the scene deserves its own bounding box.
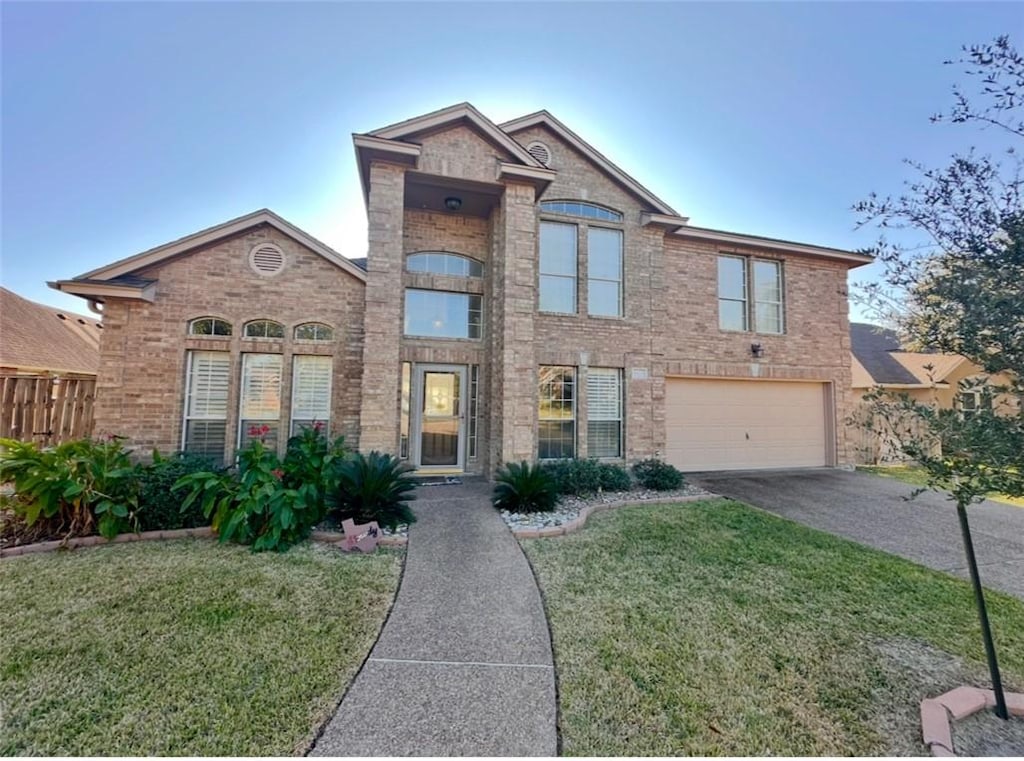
[0,375,96,447]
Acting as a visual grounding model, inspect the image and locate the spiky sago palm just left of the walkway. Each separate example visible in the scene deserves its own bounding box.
[328,452,416,529]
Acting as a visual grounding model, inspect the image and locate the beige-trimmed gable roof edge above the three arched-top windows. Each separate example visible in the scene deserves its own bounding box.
[49,209,367,301]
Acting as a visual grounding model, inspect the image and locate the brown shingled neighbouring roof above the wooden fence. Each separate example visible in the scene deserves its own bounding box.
[0,287,102,375]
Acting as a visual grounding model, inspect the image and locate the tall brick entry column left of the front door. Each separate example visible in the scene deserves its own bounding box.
[359,162,406,454]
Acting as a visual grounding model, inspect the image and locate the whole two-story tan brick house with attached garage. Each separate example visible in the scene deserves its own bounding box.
[52,103,870,473]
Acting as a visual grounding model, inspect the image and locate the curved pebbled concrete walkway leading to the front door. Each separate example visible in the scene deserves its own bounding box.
[310,481,557,756]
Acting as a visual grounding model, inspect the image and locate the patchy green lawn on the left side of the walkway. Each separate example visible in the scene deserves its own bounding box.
[0,540,401,756]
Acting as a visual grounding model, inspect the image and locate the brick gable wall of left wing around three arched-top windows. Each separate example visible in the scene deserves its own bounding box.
[95,225,364,458]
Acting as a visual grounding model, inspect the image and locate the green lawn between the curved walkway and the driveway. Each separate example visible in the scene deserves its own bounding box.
[523,500,1024,756]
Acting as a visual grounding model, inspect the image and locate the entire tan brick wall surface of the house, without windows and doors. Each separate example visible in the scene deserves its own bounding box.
[83,114,852,473]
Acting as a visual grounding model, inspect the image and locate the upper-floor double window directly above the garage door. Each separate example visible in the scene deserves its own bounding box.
[718,256,785,333]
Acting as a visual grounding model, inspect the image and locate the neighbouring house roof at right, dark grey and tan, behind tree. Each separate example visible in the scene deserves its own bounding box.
[850,323,967,388]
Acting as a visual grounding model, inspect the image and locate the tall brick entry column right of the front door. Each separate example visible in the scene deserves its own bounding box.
[490,182,538,468]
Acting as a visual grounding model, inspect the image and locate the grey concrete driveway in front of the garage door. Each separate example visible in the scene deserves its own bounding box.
[689,469,1024,599]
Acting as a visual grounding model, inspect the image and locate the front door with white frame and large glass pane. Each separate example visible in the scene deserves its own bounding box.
[413,365,466,471]
